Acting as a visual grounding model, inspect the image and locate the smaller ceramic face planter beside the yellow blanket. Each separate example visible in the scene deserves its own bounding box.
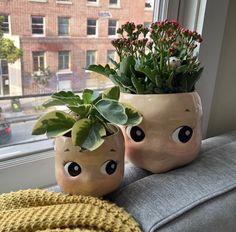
[55,126,124,197]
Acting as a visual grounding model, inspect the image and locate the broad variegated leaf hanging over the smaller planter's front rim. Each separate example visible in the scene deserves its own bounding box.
[72,119,106,151]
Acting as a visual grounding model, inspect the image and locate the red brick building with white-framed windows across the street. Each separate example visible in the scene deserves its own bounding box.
[0,0,153,95]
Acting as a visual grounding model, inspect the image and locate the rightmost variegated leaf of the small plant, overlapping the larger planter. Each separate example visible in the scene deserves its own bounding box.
[122,103,143,126]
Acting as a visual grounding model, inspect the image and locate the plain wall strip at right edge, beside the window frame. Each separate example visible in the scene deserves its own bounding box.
[207,0,236,137]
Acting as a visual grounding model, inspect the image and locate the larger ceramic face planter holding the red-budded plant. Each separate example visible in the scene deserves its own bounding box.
[121,92,202,173]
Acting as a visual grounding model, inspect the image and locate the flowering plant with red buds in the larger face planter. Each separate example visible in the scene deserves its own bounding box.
[87,20,203,94]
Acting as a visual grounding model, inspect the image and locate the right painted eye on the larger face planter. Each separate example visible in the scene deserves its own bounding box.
[172,126,193,143]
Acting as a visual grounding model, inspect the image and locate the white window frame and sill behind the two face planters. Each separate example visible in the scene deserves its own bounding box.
[0,0,229,192]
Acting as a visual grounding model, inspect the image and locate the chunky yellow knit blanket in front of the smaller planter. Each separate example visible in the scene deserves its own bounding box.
[0,189,141,232]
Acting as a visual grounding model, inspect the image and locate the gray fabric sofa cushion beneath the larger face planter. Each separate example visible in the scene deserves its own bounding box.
[107,131,236,232]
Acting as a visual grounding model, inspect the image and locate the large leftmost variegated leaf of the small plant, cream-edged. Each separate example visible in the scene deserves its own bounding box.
[32,111,76,137]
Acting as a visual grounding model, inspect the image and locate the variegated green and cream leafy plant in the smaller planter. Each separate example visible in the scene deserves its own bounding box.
[32,86,142,151]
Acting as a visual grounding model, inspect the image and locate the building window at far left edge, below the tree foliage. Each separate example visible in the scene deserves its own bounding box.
[0,60,10,96]
